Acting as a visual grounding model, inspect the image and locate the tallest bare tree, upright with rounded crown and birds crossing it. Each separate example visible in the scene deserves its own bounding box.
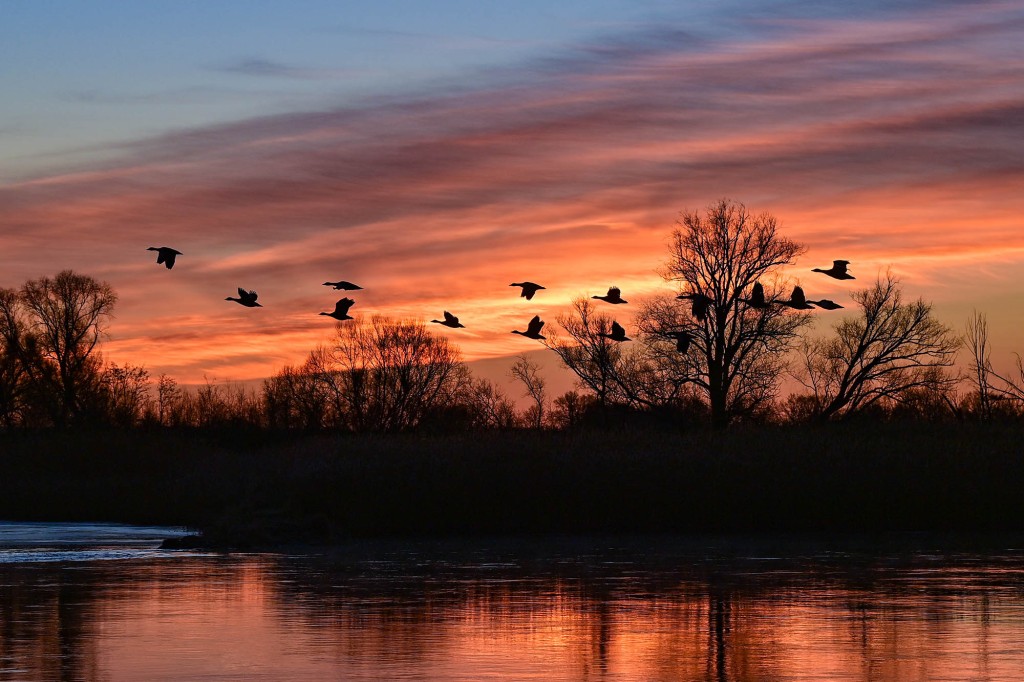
[638,199,809,428]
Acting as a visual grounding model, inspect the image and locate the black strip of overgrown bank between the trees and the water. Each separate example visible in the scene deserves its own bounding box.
[0,424,1024,547]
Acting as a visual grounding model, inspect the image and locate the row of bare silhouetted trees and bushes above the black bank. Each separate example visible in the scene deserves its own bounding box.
[6,200,1024,432]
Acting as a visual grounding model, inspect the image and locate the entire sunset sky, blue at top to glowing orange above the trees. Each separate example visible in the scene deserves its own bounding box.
[0,0,1024,391]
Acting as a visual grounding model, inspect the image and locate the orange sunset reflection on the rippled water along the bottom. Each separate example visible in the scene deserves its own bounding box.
[0,556,1024,680]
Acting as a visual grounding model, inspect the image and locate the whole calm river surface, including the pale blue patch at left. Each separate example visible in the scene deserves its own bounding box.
[0,523,1024,681]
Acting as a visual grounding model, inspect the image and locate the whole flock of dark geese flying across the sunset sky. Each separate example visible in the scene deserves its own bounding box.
[146,247,855,353]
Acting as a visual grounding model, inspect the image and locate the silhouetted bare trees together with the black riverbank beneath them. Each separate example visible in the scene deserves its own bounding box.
[0,201,1024,544]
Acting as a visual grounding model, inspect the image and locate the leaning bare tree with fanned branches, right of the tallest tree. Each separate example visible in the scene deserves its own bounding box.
[798,272,959,420]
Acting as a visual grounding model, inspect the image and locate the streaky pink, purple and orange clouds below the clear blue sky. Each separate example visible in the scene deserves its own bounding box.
[0,3,1024,379]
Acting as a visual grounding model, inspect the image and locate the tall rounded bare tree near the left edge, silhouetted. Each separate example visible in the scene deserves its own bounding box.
[19,270,118,426]
